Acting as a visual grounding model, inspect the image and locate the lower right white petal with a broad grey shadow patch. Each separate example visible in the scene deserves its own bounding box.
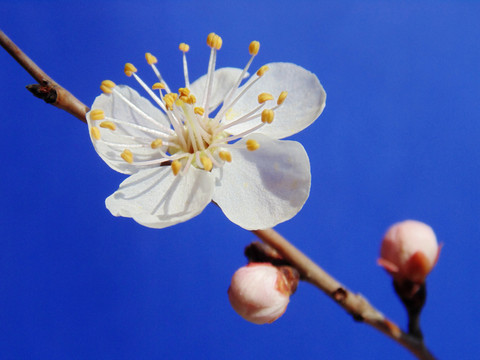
[213,134,311,230]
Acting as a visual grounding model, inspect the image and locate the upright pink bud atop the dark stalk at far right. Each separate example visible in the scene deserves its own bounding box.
[378,220,440,284]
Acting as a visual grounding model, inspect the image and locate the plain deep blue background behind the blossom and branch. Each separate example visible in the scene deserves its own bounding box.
[0,0,480,359]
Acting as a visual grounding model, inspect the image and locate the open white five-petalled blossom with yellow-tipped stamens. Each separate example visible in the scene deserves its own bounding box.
[87,33,326,230]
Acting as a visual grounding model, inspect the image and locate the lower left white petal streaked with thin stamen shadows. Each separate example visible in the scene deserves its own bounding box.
[109,166,214,229]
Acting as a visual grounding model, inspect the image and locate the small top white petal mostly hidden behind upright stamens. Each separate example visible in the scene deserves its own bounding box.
[190,68,248,112]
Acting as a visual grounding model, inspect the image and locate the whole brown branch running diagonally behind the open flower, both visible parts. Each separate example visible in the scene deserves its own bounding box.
[0,30,435,360]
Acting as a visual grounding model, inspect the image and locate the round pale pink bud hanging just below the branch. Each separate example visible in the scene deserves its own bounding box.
[228,263,298,324]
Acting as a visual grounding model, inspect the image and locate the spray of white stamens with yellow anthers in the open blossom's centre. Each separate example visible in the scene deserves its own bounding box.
[90,33,287,175]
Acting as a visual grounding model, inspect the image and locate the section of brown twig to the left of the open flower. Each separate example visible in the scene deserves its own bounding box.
[0,30,89,123]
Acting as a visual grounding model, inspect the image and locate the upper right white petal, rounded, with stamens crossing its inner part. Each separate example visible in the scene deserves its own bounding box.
[226,63,326,139]
